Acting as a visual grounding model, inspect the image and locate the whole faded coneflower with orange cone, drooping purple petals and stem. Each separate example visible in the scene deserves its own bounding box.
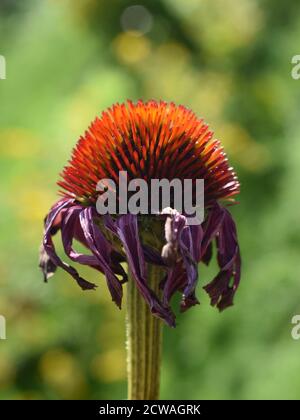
[40,101,241,399]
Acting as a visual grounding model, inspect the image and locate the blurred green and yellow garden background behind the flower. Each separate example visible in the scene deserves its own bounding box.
[0,0,300,399]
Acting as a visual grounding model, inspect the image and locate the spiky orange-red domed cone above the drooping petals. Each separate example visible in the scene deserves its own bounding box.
[58,101,239,206]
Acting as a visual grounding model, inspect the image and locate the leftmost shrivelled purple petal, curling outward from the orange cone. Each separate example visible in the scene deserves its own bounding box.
[43,200,96,290]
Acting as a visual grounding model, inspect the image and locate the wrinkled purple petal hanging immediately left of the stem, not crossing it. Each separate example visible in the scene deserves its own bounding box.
[79,207,123,308]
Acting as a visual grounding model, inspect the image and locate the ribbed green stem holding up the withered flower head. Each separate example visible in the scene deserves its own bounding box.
[126,265,162,400]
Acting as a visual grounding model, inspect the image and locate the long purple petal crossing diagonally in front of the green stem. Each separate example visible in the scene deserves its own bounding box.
[115,214,175,326]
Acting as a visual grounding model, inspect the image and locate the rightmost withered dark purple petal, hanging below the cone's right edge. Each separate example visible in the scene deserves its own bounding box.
[204,205,241,310]
